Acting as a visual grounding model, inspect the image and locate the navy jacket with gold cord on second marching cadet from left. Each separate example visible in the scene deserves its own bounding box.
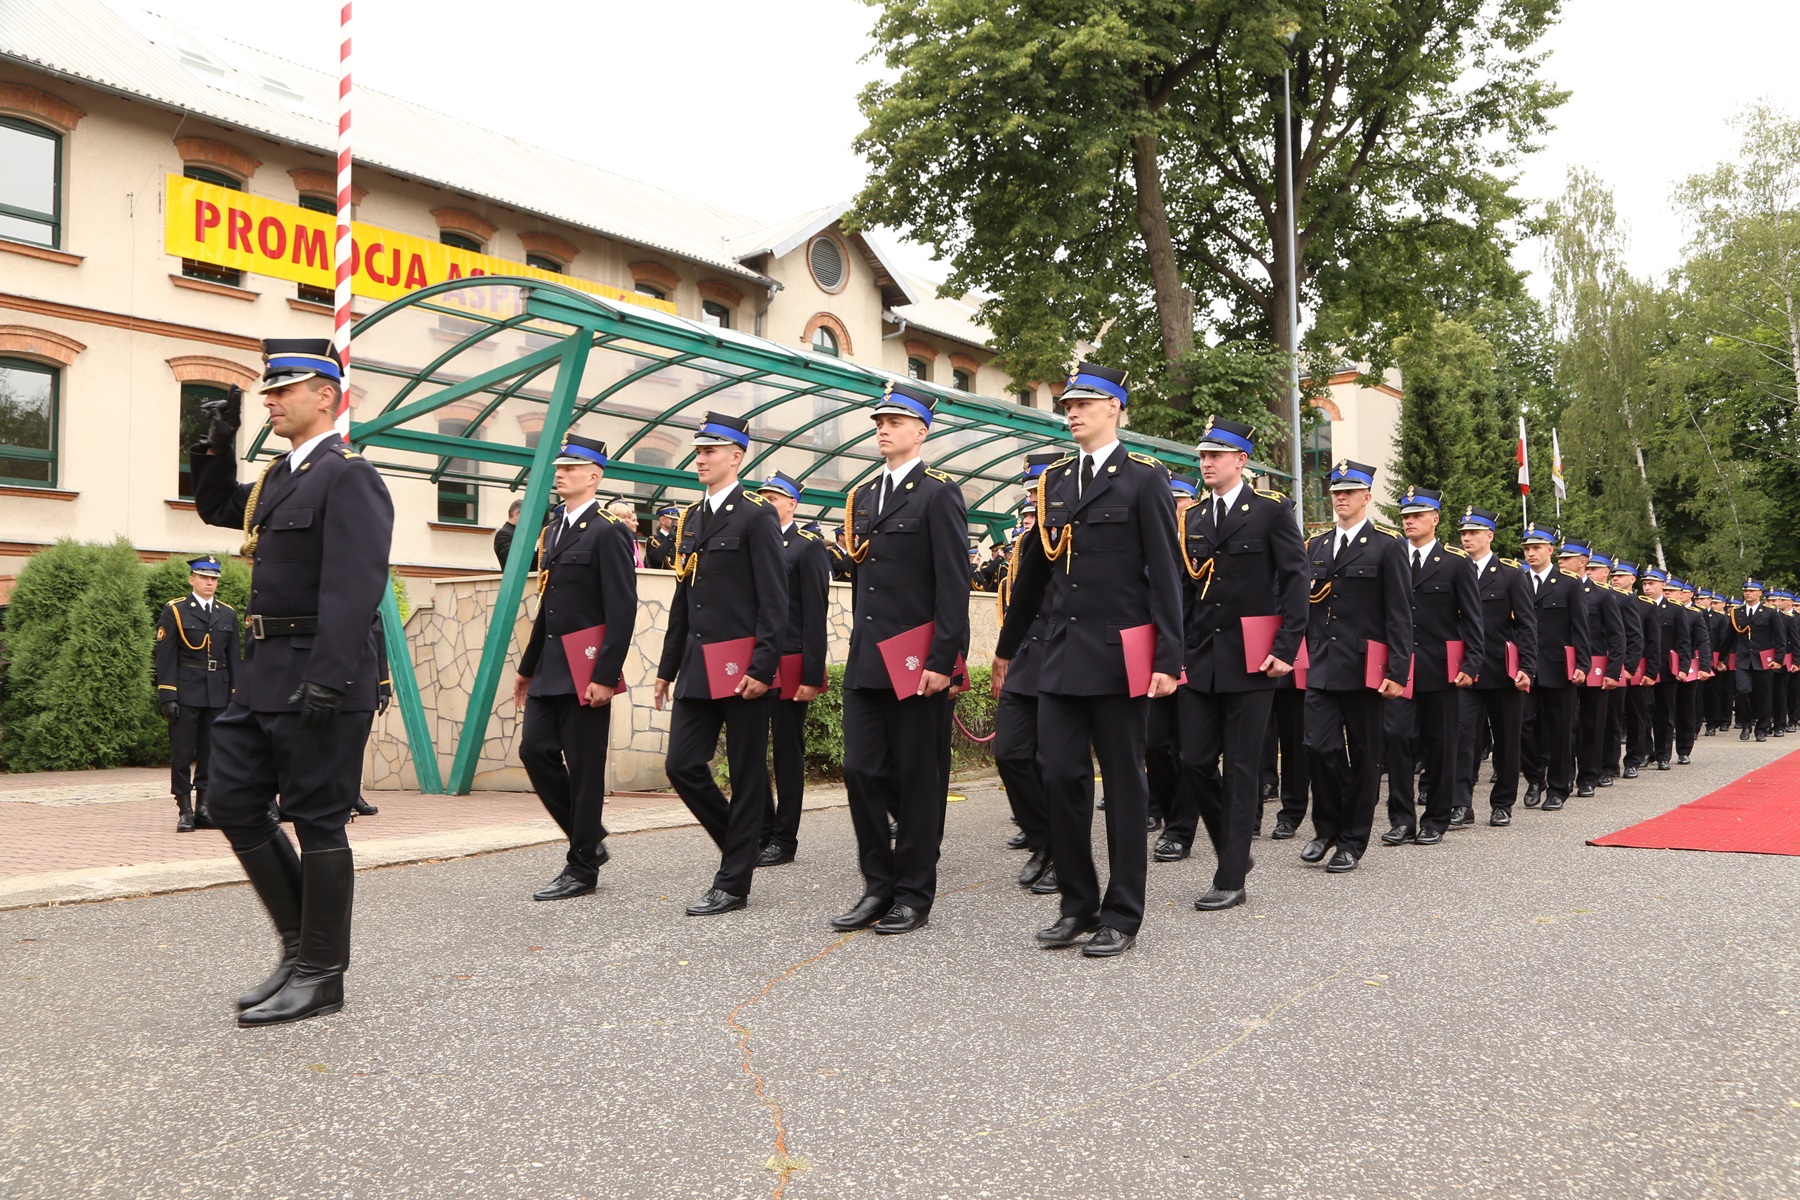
[651,484,787,700]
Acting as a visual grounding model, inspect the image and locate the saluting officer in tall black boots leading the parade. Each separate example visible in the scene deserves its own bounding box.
[191,338,394,1025]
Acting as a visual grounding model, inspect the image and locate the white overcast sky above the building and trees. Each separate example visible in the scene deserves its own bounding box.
[108,0,1800,298]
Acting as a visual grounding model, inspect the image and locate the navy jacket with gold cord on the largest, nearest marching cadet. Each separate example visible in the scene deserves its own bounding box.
[994,446,1180,696]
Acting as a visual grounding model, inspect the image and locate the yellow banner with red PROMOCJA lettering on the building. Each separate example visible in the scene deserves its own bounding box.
[162,175,675,317]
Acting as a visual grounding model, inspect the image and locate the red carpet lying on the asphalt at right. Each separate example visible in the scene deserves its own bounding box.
[1588,750,1800,855]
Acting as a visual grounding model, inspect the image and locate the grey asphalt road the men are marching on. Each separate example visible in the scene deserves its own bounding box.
[0,738,1800,1200]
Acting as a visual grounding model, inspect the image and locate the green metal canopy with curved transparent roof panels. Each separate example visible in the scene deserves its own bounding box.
[250,275,1280,793]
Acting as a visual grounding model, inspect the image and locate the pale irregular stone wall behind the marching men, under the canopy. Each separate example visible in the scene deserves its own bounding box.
[364,570,999,792]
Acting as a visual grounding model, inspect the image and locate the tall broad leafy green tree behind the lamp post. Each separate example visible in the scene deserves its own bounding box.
[857,0,1562,408]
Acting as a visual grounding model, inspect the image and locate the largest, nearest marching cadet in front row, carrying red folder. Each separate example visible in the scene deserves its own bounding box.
[994,362,1183,957]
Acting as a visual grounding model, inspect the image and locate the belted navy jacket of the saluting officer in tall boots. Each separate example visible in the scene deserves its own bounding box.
[189,434,394,712]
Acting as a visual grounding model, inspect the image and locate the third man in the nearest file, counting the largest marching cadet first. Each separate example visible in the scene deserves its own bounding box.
[1300,459,1413,873]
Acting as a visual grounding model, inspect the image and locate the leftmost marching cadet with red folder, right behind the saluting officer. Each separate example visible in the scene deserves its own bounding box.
[513,434,637,900]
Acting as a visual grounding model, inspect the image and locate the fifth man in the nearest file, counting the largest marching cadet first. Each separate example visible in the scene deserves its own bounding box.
[1451,507,1537,826]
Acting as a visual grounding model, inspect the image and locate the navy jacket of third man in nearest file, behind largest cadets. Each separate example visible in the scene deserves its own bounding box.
[1307,520,1413,691]
